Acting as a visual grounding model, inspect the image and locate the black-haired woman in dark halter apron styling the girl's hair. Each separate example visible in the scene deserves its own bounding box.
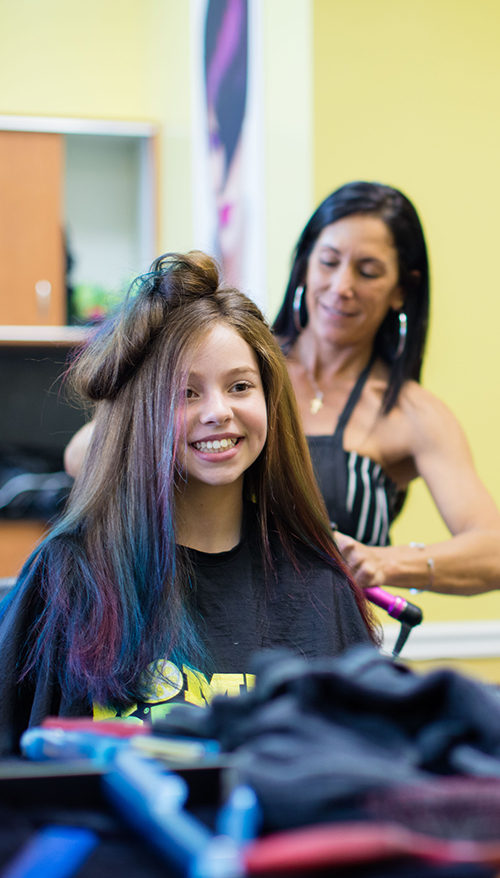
[274,182,500,595]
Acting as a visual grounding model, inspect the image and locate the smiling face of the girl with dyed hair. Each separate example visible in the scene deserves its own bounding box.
[179,323,267,487]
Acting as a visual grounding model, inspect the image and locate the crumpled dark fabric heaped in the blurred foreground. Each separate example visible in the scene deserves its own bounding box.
[155,646,500,837]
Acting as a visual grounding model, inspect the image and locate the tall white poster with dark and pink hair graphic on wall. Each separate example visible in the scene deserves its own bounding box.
[191,0,266,310]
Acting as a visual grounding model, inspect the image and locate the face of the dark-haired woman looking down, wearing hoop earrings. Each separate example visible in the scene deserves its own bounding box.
[306,214,403,345]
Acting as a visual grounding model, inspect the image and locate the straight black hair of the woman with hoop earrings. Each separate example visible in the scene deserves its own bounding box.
[273,182,429,412]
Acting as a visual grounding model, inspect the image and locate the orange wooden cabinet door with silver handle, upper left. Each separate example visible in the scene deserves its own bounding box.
[0,131,66,325]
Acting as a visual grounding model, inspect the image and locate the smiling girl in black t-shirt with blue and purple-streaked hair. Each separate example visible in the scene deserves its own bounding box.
[0,252,374,753]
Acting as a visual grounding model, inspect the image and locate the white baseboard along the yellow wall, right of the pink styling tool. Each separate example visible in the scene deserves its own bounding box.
[382,619,500,661]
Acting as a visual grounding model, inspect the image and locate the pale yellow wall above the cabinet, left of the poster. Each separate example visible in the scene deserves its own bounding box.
[0,0,191,250]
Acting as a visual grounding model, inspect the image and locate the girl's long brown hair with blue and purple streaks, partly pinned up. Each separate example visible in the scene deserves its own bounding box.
[22,251,375,705]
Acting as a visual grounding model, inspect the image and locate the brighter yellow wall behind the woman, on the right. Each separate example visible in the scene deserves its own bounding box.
[314,0,500,621]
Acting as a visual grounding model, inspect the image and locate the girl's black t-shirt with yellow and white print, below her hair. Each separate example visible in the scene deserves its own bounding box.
[0,506,369,755]
